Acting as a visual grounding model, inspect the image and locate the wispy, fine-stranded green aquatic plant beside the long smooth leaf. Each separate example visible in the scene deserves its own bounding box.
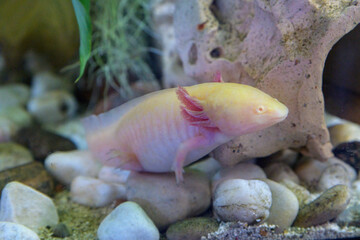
[73,0,154,97]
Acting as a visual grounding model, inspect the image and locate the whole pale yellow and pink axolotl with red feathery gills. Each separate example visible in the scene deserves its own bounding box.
[83,75,288,182]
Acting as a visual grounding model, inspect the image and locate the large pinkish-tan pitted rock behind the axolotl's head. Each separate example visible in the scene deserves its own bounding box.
[174,0,360,165]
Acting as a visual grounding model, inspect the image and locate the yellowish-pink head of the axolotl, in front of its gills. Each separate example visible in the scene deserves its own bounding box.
[204,83,289,136]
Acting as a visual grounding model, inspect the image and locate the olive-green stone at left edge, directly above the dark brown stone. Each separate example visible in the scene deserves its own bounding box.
[0,142,34,171]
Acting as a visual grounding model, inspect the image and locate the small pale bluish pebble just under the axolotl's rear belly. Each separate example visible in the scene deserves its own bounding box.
[98,166,131,184]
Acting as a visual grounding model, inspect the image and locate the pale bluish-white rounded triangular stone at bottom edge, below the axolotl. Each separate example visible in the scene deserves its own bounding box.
[97,202,160,240]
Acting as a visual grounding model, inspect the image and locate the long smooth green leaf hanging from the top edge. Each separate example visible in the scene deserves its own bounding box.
[72,0,91,82]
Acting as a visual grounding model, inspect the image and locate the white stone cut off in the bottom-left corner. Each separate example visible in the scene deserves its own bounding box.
[0,222,40,240]
